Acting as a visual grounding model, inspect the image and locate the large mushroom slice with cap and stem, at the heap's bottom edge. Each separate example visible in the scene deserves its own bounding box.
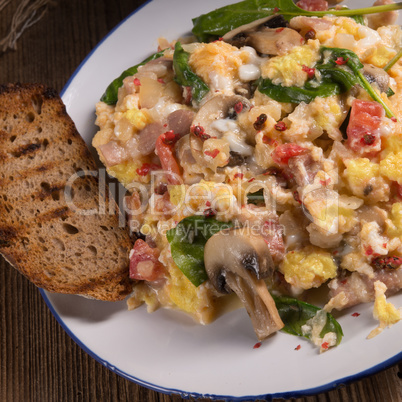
[204,229,284,340]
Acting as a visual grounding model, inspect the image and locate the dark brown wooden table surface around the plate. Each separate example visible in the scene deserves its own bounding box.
[0,0,402,402]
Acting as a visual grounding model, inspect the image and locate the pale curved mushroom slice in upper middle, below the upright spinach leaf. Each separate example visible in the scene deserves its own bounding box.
[190,95,251,163]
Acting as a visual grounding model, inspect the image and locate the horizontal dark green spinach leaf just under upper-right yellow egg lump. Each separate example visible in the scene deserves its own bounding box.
[258,78,341,103]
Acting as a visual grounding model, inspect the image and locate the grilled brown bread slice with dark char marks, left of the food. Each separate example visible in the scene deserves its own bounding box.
[0,84,132,301]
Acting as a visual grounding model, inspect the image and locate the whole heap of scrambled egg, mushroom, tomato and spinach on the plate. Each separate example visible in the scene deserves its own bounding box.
[93,0,402,350]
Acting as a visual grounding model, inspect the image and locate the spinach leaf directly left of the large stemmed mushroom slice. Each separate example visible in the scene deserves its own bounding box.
[166,215,233,286]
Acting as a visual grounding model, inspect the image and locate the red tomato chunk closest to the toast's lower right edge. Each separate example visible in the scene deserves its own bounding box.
[130,239,165,281]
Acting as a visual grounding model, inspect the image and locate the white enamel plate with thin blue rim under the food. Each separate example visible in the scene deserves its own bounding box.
[42,0,402,400]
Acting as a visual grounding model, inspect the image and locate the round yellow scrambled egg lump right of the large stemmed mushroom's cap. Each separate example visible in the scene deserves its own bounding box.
[280,246,337,289]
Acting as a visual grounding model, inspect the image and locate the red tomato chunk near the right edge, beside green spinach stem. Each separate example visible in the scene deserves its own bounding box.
[346,99,385,157]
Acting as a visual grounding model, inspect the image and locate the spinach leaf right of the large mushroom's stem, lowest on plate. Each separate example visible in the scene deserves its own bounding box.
[273,296,343,345]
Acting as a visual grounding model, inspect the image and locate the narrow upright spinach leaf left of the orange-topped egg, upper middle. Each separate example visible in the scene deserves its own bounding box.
[173,42,209,102]
